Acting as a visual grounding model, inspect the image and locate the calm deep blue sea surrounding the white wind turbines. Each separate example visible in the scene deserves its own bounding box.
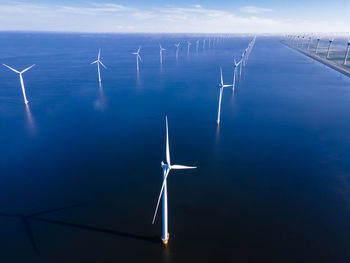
[0,33,350,263]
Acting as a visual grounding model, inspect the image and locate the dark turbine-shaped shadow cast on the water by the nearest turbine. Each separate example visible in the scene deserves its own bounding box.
[0,205,161,255]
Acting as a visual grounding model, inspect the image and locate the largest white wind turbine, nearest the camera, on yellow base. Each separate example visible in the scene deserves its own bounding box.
[152,117,197,245]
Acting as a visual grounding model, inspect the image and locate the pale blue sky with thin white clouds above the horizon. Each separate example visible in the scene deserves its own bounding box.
[0,0,350,33]
